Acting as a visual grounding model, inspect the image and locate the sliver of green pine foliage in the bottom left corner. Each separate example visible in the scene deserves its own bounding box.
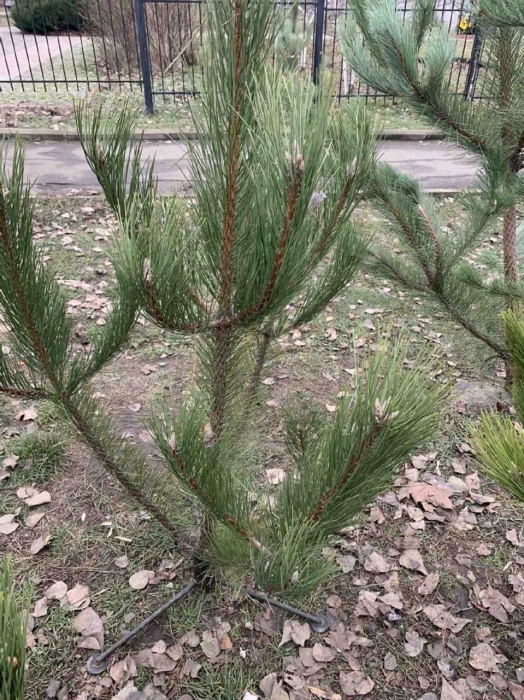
[0,557,27,700]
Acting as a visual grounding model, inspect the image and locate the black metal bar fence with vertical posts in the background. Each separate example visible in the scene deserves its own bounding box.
[0,0,486,111]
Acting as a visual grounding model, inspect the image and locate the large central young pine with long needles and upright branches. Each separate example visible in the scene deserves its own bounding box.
[0,0,445,599]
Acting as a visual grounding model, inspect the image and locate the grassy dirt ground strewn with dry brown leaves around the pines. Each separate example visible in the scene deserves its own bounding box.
[0,198,524,700]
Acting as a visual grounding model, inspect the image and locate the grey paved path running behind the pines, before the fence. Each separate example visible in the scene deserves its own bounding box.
[6,141,476,194]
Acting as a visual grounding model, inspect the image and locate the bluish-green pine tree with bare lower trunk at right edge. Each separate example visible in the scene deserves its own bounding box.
[344,0,524,360]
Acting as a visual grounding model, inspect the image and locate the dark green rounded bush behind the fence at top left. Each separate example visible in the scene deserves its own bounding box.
[11,0,85,34]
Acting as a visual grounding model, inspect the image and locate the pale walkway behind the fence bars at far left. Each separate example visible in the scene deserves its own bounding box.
[0,25,81,83]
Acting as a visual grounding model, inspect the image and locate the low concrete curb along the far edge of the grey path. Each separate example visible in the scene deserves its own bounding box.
[0,128,445,141]
